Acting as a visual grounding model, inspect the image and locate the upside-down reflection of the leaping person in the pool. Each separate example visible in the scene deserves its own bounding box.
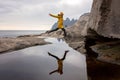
[48,50,69,74]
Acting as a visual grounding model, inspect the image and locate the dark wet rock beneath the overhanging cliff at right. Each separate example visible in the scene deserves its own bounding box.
[91,41,120,65]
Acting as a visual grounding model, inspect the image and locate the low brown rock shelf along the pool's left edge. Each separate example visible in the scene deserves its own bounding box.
[0,35,49,54]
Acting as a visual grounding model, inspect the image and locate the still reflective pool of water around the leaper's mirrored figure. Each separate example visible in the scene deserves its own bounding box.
[0,38,87,80]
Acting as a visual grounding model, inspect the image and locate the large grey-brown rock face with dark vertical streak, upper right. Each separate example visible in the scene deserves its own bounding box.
[87,0,120,38]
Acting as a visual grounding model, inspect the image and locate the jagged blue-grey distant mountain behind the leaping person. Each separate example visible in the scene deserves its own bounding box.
[51,18,77,30]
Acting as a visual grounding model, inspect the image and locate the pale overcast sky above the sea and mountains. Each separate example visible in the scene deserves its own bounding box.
[0,0,92,30]
